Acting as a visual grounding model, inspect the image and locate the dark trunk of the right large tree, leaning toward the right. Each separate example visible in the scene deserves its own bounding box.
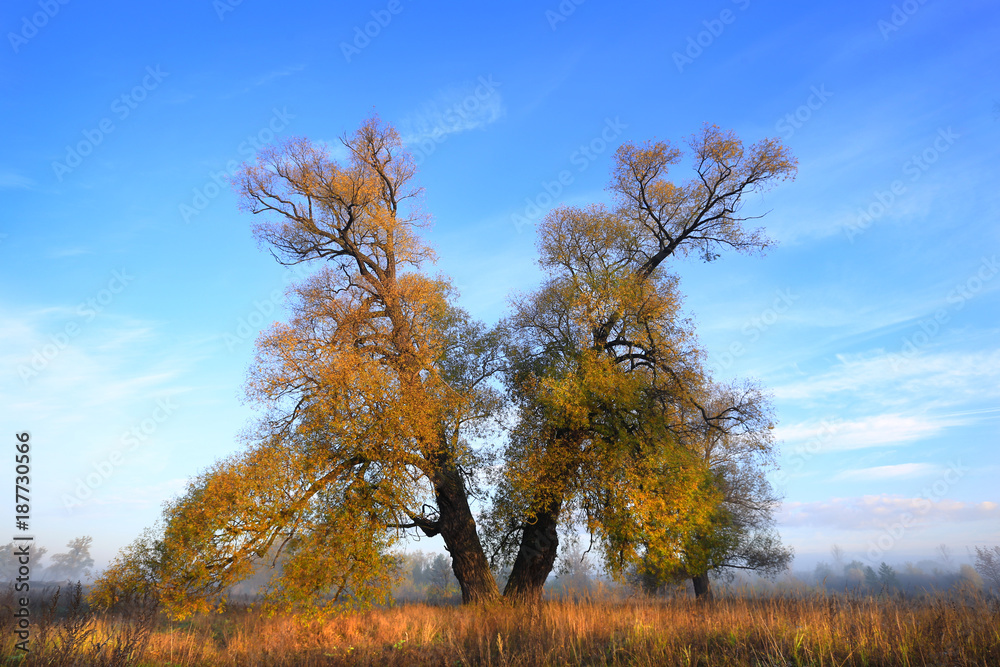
[503,502,562,602]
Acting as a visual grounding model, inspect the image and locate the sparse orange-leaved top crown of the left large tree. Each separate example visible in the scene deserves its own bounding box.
[234,117,433,282]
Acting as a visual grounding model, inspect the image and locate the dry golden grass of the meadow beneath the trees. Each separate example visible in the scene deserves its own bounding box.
[3,595,1000,667]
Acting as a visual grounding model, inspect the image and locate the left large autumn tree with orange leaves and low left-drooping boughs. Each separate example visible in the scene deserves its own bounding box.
[98,118,499,613]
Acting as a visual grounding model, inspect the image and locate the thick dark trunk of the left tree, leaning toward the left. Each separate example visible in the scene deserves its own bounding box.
[434,467,500,604]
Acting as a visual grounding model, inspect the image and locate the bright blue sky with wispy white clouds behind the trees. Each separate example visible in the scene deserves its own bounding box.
[0,0,1000,576]
